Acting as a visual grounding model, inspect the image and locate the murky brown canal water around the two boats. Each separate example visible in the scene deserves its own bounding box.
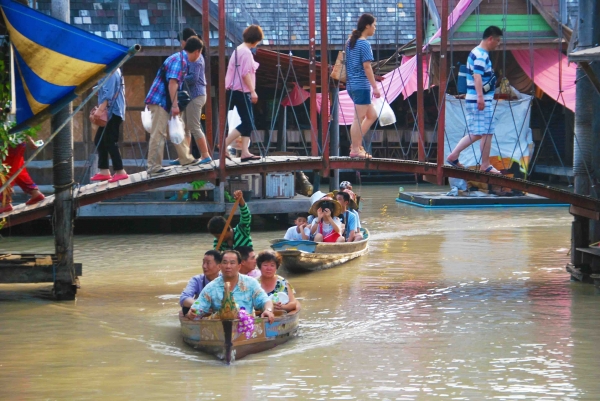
[0,186,600,400]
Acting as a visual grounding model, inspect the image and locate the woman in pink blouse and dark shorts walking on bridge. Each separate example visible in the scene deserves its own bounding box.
[225,25,263,162]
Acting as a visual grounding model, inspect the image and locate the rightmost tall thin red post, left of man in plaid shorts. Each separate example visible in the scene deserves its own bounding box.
[436,0,448,185]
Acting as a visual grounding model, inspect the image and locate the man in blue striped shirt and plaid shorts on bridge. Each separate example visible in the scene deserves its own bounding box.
[446,26,502,174]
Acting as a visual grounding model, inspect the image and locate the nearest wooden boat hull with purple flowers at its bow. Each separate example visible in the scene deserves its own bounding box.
[179,303,300,365]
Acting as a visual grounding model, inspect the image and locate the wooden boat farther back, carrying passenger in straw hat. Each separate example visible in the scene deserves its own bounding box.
[271,228,369,273]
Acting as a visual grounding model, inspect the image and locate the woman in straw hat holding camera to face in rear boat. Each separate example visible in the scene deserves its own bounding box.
[308,192,345,242]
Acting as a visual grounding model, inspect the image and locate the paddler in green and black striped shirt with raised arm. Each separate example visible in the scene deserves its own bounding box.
[208,190,253,252]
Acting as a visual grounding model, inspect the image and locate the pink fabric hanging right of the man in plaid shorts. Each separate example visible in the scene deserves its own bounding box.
[512,49,577,112]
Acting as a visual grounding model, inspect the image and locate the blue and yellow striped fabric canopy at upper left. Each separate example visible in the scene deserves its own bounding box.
[0,0,128,131]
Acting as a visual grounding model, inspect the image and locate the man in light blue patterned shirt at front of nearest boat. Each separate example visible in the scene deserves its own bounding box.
[186,251,275,323]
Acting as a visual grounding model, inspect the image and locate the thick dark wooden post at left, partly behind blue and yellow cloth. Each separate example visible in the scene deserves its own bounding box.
[51,0,77,300]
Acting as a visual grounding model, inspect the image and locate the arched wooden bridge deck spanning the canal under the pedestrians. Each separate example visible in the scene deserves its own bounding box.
[0,156,600,227]
